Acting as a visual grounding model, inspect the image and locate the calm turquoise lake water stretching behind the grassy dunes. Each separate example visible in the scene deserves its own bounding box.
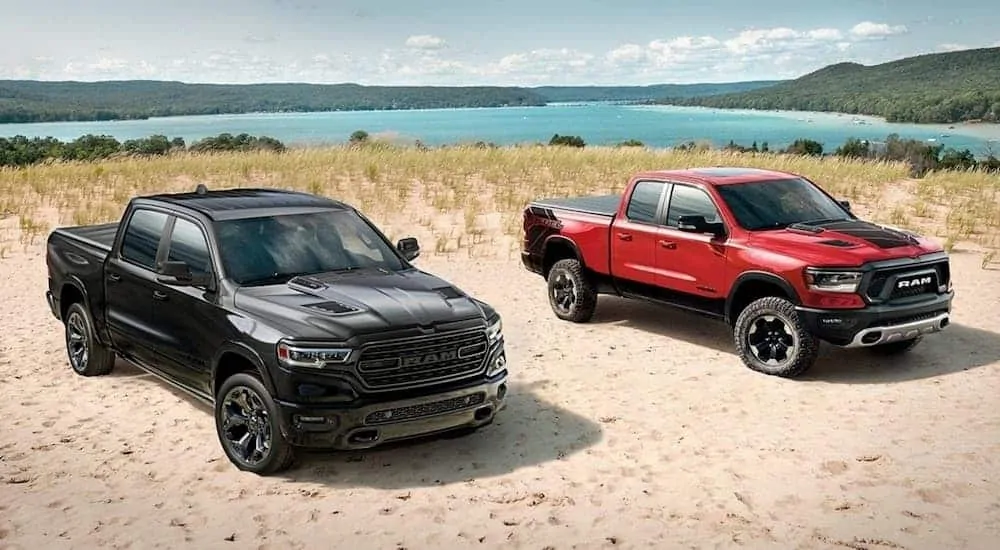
[0,104,1000,155]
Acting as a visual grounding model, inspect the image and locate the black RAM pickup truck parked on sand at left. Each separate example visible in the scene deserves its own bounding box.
[46,185,507,475]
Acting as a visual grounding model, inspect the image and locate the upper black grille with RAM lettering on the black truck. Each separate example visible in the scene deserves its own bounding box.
[358,329,489,390]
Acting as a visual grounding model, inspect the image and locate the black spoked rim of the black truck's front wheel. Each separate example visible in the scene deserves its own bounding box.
[222,386,272,466]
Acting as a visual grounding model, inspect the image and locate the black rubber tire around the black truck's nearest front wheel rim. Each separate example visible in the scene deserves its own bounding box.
[215,372,295,476]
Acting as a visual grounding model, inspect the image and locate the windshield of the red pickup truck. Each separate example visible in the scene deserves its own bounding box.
[716,178,852,231]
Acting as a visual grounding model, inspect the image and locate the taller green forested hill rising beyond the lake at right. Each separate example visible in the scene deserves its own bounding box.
[655,48,1000,123]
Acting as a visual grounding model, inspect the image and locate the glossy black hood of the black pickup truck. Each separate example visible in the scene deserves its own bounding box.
[228,269,495,340]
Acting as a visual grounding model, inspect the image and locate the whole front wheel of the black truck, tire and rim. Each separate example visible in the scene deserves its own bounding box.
[215,372,295,475]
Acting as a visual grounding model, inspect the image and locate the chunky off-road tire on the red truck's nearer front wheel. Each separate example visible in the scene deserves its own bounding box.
[733,296,819,378]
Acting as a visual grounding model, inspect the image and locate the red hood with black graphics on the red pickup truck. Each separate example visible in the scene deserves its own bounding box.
[750,220,941,266]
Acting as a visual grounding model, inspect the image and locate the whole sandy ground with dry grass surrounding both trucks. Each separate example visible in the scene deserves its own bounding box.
[0,147,1000,550]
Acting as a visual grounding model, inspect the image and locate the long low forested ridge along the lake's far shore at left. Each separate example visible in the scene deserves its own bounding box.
[0,80,772,123]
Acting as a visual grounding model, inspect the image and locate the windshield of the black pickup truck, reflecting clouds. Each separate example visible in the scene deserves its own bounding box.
[216,210,404,285]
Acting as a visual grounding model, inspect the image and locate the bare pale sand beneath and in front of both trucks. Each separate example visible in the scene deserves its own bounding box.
[0,238,1000,550]
